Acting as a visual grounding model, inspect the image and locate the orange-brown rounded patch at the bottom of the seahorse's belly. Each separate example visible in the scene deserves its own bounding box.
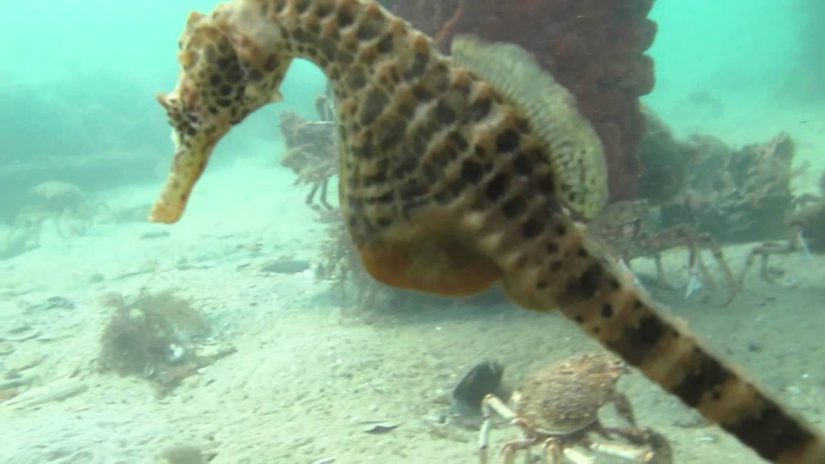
[358,232,502,296]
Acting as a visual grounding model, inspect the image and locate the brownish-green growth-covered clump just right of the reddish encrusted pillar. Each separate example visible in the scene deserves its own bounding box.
[639,111,805,243]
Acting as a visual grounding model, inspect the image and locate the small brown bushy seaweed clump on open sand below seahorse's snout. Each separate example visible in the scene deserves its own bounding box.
[100,290,211,394]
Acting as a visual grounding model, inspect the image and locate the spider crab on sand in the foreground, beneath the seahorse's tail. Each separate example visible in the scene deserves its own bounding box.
[479,352,672,464]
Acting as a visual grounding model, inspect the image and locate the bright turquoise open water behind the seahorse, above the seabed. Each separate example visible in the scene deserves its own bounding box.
[0,0,822,175]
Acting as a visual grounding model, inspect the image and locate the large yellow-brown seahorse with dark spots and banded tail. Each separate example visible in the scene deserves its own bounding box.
[150,0,825,464]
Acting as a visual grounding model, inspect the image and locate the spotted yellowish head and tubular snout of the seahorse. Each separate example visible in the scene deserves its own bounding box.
[150,8,291,223]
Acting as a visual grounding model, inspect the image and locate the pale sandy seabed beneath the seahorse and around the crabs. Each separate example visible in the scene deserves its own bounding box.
[0,156,825,464]
